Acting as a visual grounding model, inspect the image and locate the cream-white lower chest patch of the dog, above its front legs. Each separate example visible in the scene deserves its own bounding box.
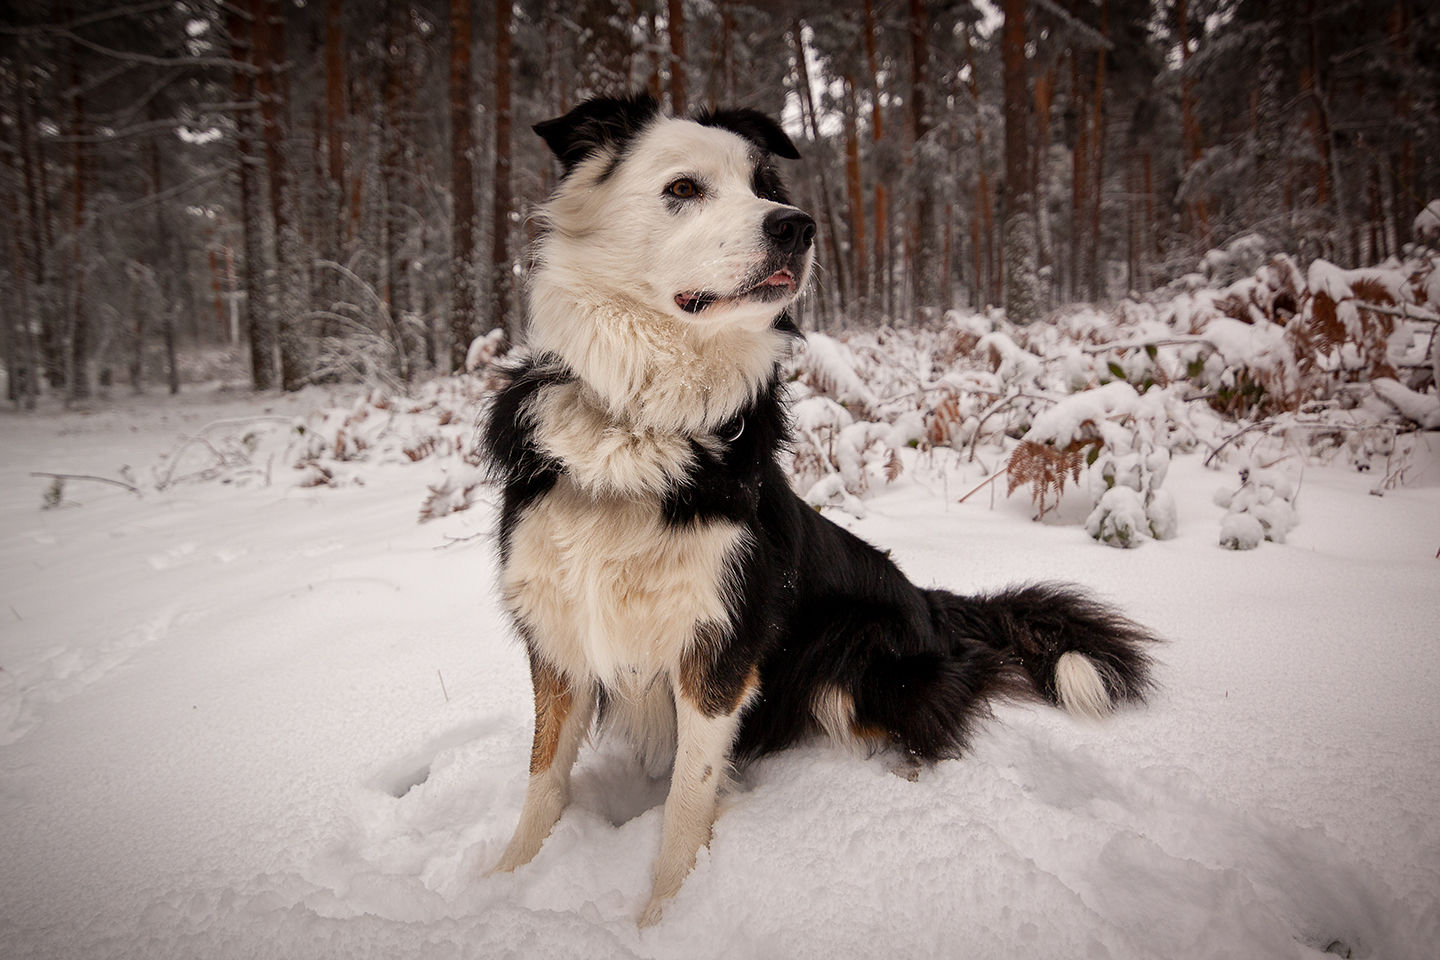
[503,476,744,691]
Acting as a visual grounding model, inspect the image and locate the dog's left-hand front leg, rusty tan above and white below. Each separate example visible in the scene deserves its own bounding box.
[490,652,595,874]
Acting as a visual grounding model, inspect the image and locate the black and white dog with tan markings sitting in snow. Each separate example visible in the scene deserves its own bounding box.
[484,96,1151,923]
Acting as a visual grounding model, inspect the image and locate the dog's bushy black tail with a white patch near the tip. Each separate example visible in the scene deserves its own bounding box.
[924,583,1155,717]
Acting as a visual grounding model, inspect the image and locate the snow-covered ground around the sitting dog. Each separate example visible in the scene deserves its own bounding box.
[0,385,1440,959]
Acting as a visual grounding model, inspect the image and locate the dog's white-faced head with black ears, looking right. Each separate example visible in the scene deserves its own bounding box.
[534,96,815,330]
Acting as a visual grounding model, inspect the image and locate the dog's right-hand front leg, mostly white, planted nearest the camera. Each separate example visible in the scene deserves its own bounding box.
[639,684,743,927]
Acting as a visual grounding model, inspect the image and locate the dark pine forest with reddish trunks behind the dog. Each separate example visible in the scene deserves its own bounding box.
[0,0,1440,407]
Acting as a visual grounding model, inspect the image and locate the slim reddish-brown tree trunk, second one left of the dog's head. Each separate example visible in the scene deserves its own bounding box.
[449,0,475,373]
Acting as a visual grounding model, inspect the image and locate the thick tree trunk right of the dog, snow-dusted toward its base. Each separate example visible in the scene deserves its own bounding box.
[1001,0,1040,324]
